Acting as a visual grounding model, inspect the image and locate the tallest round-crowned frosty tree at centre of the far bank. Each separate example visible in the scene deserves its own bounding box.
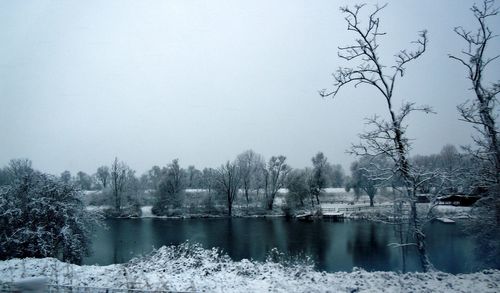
[236,150,265,209]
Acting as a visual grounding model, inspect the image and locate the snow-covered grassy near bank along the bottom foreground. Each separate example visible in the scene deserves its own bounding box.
[0,243,500,292]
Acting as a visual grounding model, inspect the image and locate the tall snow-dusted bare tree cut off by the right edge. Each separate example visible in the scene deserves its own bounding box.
[449,0,500,266]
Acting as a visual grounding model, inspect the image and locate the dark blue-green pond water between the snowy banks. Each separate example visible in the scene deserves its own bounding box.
[84,218,480,273]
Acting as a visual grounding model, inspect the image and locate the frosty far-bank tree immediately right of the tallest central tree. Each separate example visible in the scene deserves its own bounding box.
[264,156,292,210]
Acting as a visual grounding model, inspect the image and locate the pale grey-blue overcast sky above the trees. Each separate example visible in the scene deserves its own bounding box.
[0,0,500,174]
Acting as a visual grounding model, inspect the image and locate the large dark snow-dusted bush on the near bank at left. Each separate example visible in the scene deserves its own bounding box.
[0,171,100,263]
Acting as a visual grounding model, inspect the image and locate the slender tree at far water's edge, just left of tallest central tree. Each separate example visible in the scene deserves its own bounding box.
[215,161,241,216]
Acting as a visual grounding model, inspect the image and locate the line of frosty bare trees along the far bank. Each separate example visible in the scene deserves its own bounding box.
[0,141,474,216]
